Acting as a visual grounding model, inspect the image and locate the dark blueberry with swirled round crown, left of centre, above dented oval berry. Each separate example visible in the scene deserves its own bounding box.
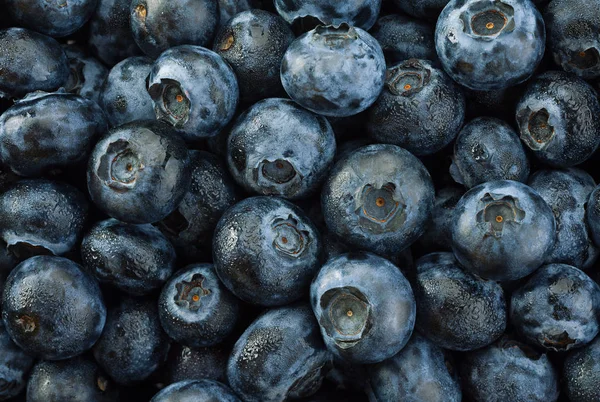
[87,120,191,224]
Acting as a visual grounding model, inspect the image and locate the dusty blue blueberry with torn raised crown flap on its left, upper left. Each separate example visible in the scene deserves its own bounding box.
[147,45,239,142]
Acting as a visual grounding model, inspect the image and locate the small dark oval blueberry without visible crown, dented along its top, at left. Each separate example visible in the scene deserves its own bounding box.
[81,219,176,296]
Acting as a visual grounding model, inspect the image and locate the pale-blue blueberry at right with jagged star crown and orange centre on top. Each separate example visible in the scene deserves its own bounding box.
[452,180,556,281]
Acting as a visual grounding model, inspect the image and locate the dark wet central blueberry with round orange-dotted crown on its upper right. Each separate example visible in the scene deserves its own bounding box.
[213,197,322,306]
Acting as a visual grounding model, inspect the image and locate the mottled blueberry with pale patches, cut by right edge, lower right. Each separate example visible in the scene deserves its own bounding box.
[510,264,600,352]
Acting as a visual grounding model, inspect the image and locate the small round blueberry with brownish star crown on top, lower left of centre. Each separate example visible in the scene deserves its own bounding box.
[158,264,239,348]
